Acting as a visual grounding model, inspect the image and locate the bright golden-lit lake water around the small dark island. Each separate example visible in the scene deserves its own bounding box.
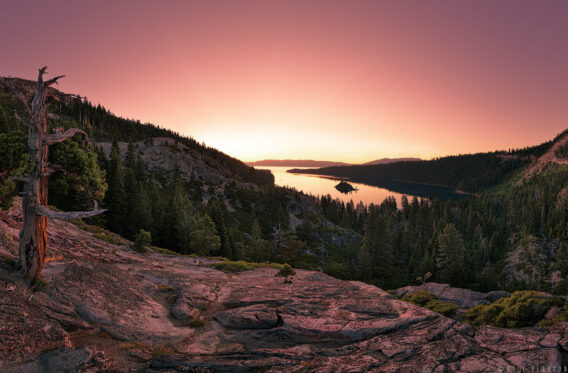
[255,167,412,207]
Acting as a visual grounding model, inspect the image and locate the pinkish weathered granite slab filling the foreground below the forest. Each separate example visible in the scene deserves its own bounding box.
[0,203,568,372]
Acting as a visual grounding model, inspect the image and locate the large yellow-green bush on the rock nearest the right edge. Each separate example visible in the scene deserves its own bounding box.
[463,291,566,328]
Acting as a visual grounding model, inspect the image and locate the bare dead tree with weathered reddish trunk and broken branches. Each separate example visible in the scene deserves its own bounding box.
[2,67,106,286]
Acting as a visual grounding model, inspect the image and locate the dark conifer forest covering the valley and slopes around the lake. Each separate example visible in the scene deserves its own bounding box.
[0,76,568,293]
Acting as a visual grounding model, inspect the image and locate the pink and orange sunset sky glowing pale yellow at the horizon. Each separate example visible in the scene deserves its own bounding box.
[0,0,568,162]
